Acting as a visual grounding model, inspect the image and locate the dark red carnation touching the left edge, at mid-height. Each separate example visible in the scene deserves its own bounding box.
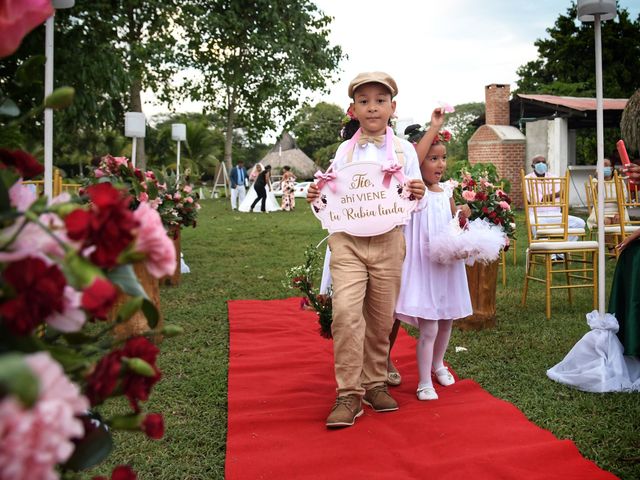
[0,257,67,335]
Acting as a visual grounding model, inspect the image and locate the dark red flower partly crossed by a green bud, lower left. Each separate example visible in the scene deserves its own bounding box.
[122,337,161,411]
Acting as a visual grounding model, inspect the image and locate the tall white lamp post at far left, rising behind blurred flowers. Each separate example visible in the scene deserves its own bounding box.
[44,0,75,198]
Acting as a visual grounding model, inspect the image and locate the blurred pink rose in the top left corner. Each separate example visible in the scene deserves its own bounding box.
[0,0,53,57]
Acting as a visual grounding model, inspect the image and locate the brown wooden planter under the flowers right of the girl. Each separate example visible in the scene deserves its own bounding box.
[453,260,499,330]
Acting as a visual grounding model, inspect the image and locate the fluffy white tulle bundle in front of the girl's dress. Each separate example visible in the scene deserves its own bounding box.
[424,215,507,265]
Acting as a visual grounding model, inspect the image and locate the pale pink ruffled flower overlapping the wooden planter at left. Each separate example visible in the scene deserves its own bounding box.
[133,202,176,278]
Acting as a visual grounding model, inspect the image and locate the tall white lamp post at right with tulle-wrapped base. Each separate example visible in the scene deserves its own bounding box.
[578,0,616,316]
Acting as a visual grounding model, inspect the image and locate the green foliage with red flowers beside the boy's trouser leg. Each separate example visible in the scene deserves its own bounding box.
[284,245,332,338]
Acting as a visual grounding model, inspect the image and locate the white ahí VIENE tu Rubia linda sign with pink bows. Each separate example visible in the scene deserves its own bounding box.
[311,128,418,237]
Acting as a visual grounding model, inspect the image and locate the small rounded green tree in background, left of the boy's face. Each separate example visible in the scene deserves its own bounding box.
[290,102,344,158]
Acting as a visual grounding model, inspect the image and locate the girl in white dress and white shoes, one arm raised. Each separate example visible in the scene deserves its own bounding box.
[396,134,473,400]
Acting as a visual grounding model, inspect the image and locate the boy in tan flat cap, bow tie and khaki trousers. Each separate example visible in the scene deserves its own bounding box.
[307,72,425,428]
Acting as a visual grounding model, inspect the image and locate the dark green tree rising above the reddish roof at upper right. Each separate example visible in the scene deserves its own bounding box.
[514,3,640,98]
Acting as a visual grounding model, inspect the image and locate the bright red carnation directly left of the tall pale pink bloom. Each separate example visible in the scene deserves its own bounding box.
[65,183,138,268]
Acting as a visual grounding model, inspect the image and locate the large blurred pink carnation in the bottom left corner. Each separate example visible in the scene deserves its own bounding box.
[0,352,89,480]
